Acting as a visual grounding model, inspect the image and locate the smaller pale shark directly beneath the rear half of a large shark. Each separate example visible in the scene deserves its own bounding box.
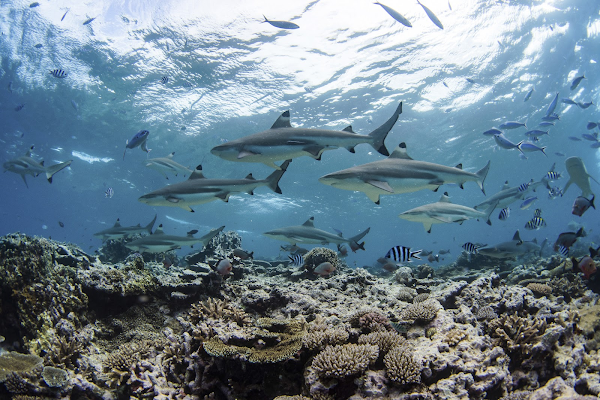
[399,192,496,233]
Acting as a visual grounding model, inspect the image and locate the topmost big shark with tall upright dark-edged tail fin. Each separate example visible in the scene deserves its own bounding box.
[210,103,402,169]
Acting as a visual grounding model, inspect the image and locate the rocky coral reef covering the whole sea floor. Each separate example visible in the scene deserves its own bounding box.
[0,232,600,400]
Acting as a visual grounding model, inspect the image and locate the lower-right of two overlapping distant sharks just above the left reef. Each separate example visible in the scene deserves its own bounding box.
[125,224,225,253]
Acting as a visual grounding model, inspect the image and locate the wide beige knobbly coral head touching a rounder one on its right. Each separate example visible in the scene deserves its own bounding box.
[312,344,379,378]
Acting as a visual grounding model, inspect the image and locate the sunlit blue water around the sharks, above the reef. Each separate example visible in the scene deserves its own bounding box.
[0,0,600,266]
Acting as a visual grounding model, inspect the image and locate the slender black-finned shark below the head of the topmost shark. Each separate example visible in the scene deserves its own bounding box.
[138,160,291,212]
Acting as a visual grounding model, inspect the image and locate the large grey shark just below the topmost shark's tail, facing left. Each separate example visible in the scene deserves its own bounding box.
[319,142,490,204]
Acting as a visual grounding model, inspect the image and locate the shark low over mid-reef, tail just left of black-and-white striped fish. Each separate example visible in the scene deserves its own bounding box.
[263,217,371,250]
